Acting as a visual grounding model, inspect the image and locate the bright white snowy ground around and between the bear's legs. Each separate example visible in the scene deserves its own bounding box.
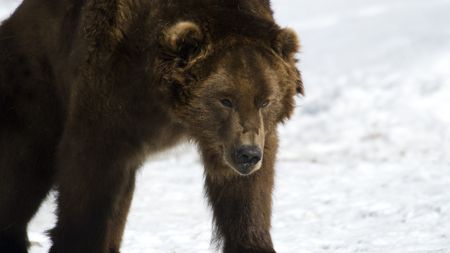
[0,0,450,253]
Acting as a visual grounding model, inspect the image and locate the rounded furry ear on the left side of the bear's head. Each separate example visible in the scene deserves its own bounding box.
[162,21,204,68]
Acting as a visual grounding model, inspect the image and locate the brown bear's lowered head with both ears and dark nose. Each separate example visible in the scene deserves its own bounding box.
[158,17,303,178]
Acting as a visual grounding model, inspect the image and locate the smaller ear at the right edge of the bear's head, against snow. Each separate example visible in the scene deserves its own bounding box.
[274,28,300,61]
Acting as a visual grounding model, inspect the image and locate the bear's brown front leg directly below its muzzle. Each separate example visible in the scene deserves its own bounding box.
[205,134,277,253]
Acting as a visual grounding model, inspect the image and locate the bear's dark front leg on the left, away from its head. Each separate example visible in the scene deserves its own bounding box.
[50,103,142,253]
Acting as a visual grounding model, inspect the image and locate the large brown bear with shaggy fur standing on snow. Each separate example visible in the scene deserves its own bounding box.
[0,0,303,253]
